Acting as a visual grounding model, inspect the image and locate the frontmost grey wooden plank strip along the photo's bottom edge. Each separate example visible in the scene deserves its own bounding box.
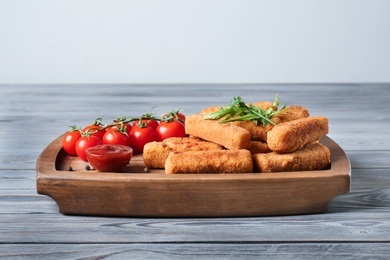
[0,243,390,260]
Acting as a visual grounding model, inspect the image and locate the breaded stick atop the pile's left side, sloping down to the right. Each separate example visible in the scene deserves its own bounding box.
[185,115,251,150]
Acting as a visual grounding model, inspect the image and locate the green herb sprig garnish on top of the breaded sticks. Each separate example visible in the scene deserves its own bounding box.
[203,95,286,126]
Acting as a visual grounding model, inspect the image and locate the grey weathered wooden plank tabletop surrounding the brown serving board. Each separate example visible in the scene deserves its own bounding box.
[0,84,390,259]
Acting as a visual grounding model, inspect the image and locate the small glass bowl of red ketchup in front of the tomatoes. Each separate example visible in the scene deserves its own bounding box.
[85,144,133,172]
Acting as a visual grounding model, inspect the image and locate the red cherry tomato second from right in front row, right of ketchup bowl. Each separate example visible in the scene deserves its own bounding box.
[130,125,157,152]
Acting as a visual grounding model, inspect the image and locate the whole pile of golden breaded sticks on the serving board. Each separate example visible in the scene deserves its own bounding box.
[143,102,330,174]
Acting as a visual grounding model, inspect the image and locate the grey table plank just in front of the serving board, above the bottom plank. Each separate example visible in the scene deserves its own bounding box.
[0,211,390,244]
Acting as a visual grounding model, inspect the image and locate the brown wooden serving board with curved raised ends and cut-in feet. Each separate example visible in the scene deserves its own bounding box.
[36,136,351,217]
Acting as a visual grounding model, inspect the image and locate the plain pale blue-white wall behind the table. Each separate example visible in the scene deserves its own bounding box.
[0,0,390,84]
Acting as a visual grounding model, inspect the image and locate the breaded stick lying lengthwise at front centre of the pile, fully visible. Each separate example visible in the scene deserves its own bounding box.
[165,149,253,174]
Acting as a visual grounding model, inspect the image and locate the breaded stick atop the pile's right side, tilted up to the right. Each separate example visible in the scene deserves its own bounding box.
[267,116,329,153]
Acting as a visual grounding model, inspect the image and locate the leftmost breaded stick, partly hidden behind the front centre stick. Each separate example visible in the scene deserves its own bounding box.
[143,137,223,168]
